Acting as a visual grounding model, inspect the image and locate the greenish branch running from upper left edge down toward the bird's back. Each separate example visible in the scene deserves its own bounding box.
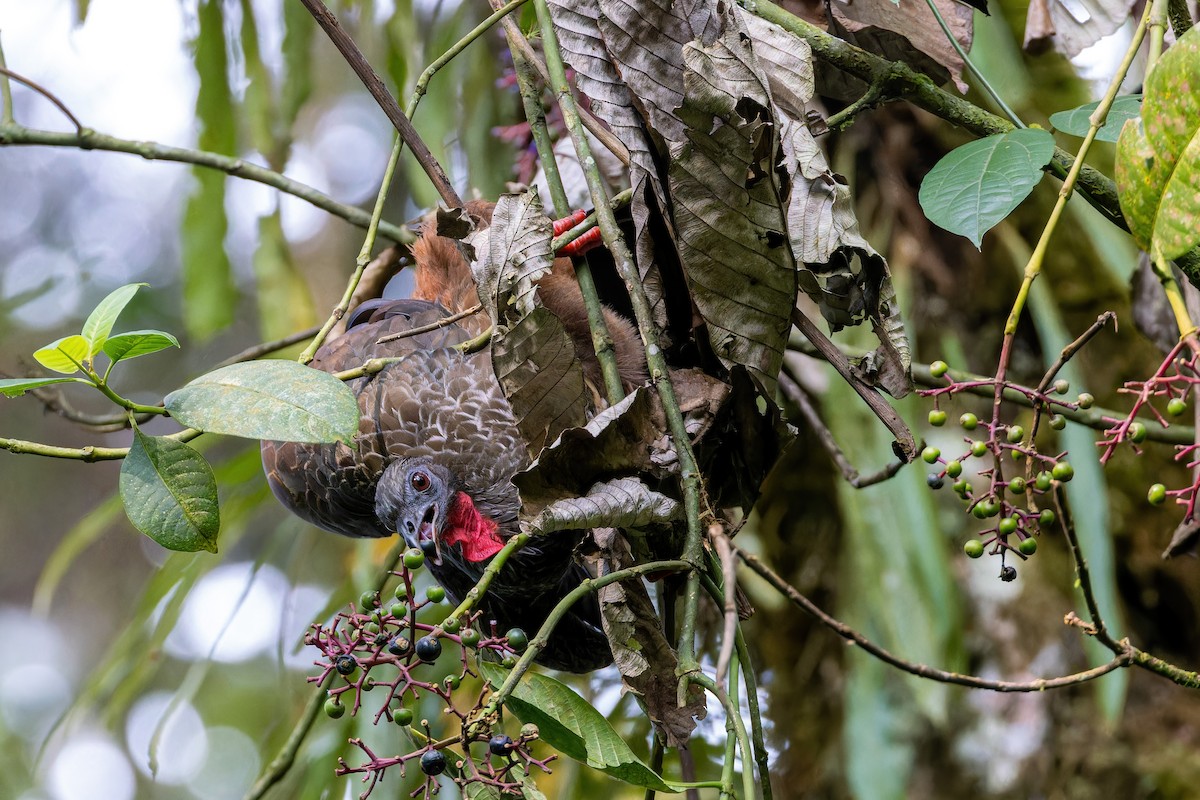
[0,125,414,243]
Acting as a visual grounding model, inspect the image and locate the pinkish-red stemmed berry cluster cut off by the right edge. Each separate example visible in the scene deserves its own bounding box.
[1097,339,1200,524]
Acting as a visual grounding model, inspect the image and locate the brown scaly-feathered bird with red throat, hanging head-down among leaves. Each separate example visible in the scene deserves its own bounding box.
[262,203,646,673]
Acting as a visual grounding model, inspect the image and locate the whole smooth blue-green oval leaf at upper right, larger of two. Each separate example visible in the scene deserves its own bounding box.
[919,128,1054,247]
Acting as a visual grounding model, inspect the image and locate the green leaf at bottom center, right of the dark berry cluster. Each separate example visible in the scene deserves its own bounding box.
[479,661,678,793]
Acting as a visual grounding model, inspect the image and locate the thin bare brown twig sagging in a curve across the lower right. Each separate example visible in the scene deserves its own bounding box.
[733,546,1134,692]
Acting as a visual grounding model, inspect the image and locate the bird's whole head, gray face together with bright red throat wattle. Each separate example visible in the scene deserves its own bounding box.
[376,458,504,565]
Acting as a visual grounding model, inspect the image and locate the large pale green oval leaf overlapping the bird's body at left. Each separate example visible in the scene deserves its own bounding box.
[163,361,359,443]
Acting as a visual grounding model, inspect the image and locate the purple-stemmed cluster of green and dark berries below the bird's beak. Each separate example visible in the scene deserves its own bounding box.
[305,549,554,798]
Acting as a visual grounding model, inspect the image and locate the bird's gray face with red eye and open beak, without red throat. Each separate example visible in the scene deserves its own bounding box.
[376,458,455,564]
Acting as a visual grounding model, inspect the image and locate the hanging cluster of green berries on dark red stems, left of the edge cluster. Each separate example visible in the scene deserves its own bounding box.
[920,361,1094,581]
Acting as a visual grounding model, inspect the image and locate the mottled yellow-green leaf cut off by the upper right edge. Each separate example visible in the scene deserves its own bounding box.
[1116,29,1200,259]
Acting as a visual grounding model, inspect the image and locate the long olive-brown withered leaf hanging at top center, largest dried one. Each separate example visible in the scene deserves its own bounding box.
[668,6,797,390]
